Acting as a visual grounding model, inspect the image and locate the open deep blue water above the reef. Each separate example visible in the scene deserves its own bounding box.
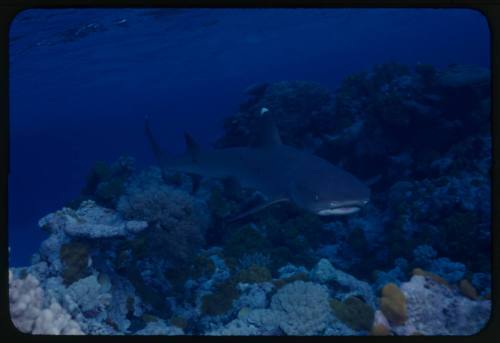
[9,9,490,266]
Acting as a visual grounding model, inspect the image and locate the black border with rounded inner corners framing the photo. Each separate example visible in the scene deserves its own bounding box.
[0,0,500,342]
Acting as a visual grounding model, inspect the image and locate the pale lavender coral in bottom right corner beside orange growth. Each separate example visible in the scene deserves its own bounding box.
[392,275,491,335]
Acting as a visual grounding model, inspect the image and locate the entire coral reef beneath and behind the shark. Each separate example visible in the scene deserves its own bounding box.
[9,63,491,335]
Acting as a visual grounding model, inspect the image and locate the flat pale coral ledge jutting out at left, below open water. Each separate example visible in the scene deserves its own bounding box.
[38,200,148,239]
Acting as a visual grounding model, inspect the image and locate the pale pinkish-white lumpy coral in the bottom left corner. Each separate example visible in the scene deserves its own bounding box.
[9,270,83,335]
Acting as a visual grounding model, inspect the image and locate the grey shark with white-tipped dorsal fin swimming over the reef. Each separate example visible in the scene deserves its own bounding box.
[145,108,370,220]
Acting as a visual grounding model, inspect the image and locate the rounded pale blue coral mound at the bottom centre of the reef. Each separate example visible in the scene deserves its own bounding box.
[271,281,331,336]
